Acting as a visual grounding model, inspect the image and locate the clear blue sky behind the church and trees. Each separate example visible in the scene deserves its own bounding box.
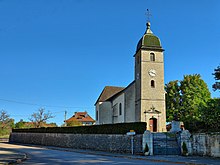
[0,0,220,125]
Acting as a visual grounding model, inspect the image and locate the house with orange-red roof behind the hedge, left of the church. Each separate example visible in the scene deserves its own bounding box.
[65,111,95,126]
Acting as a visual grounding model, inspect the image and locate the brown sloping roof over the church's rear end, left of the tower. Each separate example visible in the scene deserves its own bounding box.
[95,86,125,105]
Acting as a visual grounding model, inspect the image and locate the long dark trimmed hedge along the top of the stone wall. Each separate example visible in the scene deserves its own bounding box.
[12,122,146,134]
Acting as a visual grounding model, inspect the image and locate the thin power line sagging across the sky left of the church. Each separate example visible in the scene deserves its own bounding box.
[0,98,94,109]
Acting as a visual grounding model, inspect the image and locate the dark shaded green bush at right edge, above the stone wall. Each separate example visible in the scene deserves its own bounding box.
[201,98,220,130]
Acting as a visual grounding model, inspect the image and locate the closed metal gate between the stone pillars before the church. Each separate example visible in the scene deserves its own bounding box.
[153,133,181,155]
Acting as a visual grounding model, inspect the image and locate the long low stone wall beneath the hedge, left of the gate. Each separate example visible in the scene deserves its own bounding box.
[9,133,143,154]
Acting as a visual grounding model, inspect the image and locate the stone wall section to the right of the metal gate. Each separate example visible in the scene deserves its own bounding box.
[192,132,220,157]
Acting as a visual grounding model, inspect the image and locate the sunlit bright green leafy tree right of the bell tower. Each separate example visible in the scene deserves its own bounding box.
[180,74,211,122]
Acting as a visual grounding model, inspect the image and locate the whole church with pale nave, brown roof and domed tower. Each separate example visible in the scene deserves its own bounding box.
[95,22,166,132]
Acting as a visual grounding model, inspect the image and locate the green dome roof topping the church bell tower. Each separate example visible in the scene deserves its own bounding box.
[136,22,162,51]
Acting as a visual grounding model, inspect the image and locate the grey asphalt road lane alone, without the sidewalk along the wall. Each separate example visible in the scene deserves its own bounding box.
[1,143,170,165]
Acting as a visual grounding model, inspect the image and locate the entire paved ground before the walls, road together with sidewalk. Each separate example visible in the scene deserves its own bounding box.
[0,143,220,165]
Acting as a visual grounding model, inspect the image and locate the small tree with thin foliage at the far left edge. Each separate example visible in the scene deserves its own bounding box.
[0,110,14,136]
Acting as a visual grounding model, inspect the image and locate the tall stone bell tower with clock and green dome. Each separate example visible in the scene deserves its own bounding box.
[134,22,166,132]
